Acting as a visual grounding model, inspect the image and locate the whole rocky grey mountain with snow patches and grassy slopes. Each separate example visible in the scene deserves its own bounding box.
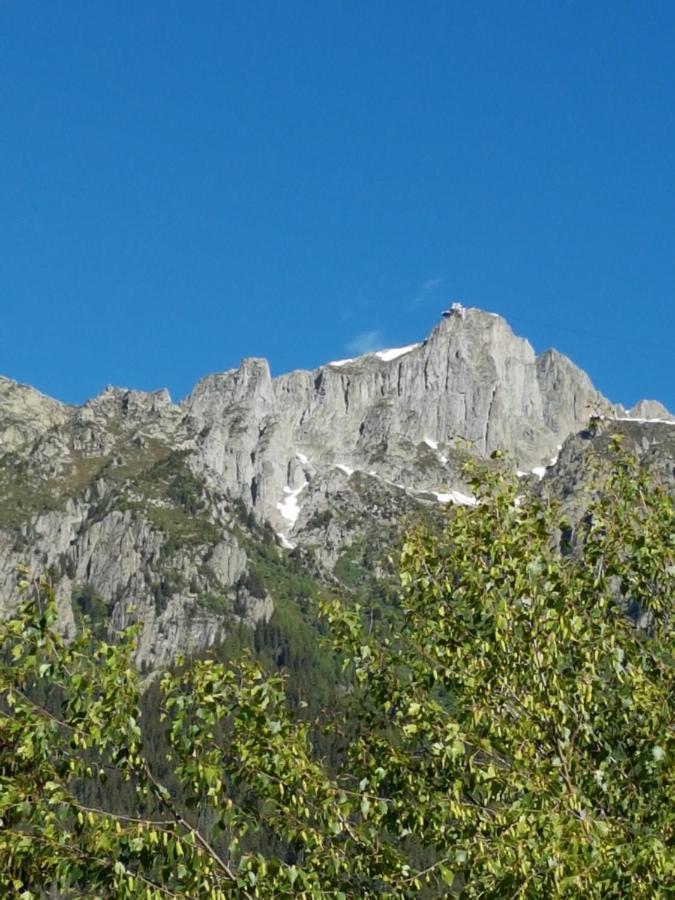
[0,308,675,671]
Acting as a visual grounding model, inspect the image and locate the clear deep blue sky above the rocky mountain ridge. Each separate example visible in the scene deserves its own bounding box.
[0,0,675,408]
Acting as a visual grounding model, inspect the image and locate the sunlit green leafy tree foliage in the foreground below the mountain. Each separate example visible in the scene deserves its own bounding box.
[0,442,675,900]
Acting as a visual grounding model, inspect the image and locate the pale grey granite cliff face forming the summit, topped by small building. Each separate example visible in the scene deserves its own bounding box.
[183,309,614,529]
